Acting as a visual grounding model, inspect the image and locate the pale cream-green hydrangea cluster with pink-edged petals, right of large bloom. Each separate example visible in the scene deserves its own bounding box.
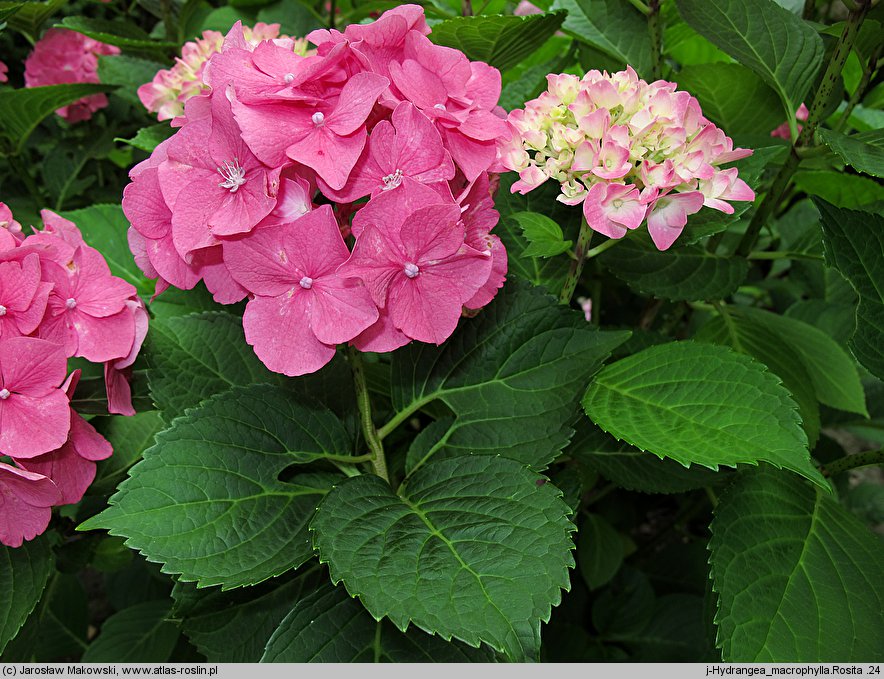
[500,68,755,250]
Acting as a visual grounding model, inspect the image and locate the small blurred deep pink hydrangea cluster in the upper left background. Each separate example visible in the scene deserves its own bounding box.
[25,28,120,123]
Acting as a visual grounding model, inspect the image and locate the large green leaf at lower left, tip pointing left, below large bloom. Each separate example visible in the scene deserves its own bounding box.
[80,385,352,589]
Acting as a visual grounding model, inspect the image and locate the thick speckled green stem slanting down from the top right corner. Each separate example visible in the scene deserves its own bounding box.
[736,0,871,257]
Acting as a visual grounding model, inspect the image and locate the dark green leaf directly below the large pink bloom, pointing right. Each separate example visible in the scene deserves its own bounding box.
[391,282,628,471]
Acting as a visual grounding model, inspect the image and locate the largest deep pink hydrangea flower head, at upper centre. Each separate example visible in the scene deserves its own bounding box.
[123,5,509,376]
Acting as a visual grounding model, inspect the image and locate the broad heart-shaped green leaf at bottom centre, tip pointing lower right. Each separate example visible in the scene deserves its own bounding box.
[311,455,574,660]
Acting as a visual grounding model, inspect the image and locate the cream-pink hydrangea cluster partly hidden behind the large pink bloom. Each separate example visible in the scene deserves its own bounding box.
[138,22,308,120]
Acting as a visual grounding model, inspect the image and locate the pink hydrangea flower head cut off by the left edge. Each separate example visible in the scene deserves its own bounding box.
[0,203,147,547]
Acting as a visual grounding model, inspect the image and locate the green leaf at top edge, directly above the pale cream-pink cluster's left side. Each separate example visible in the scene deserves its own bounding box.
[430,12,565,71]
